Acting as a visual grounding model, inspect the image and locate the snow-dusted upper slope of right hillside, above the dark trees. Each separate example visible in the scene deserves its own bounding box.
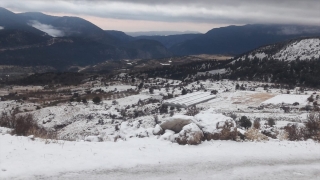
[236,38,320,61]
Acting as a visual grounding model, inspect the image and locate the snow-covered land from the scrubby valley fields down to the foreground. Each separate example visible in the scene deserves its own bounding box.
[0,78,320,180]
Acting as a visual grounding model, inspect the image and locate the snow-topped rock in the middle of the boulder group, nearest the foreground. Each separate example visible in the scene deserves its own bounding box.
[176,123,204,145]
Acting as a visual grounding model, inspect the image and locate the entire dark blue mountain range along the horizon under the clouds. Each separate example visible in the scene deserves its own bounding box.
[0,8,320,70]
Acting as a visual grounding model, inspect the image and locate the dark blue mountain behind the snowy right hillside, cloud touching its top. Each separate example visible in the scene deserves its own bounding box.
[170,24,320,55]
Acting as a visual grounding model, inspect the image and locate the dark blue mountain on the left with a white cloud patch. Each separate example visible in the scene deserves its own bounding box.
[0,8,171,70]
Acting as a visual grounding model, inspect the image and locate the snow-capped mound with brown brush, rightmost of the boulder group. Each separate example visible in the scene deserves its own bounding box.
[194,109,237,141]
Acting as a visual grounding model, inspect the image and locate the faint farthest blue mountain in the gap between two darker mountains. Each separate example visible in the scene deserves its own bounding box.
[135,34,201,48]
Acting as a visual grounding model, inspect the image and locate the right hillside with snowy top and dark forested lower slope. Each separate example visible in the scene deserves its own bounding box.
[224,37,320,87]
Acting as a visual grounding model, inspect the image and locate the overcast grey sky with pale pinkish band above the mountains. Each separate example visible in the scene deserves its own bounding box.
[0,0,320,33]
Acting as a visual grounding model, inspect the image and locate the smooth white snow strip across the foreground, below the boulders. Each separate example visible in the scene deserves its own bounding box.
[0,135,320,180]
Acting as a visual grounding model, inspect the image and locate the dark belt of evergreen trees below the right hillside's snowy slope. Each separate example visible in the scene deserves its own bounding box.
[227,58,320,87]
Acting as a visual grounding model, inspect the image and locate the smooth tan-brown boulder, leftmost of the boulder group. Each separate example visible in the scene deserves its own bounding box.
[160,115,194,133]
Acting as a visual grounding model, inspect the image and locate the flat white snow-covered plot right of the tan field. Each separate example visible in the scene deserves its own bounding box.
[261,94,310,105]
